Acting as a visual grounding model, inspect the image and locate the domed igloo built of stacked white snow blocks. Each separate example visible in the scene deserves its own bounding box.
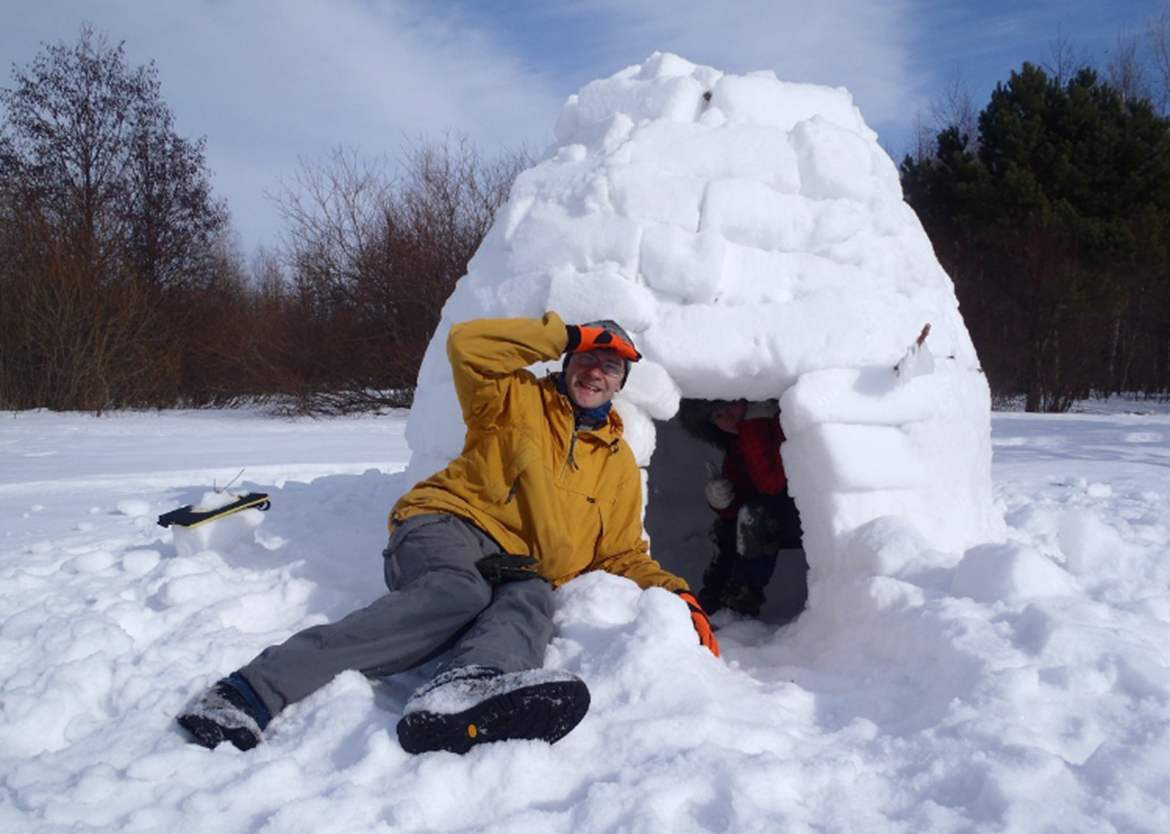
[407,54,1003,609]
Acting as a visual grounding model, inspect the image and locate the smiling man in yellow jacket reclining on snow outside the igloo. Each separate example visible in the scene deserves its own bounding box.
[178,312,718,752]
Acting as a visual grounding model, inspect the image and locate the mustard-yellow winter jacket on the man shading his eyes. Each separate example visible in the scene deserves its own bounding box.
[391,312,687,591]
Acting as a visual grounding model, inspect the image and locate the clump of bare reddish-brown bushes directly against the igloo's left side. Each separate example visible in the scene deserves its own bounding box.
[275,135,529,411]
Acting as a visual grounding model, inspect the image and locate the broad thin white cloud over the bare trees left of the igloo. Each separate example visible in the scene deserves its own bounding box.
[0,0,567,248]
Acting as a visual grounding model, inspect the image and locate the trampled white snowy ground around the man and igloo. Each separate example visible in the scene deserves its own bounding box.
[0,404,1170,834]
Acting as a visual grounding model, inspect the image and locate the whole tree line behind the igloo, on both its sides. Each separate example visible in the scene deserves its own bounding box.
[0,22,1170,413]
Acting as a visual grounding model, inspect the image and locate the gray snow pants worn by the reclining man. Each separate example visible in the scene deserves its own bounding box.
[240,514,553,716]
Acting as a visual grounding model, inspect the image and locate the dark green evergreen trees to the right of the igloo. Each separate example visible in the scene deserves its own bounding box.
[901,14,1170,412]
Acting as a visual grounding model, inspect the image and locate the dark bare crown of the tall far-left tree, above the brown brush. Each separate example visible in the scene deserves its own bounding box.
[0,26,228,285]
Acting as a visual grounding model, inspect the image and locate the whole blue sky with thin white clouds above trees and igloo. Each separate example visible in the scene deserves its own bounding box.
[0,0,1170,253]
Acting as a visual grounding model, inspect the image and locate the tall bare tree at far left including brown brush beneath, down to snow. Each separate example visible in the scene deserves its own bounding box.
[0,26,234,411]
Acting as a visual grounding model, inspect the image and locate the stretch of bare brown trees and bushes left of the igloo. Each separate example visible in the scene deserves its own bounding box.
[0,27,530,412]
